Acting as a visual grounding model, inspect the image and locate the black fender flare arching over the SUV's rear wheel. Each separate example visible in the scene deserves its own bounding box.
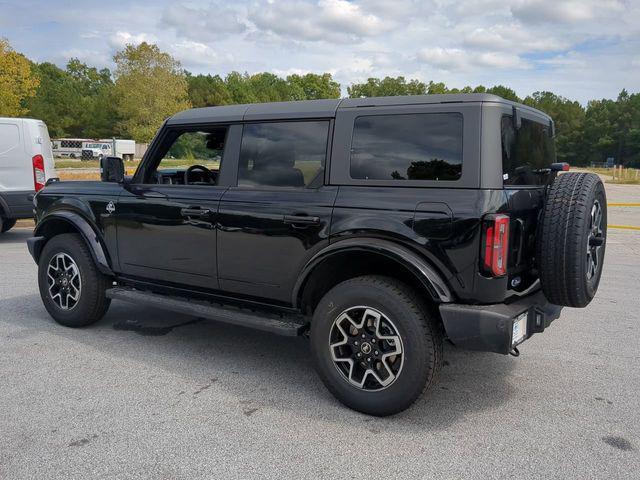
[291,238,453,306]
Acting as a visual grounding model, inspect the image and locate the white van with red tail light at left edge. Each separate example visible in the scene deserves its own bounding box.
[0,117,55,233]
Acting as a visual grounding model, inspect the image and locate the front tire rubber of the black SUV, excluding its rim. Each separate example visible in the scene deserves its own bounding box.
[38,233,111,327]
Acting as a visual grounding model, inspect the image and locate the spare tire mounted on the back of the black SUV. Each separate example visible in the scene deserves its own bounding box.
[536,172,607,307]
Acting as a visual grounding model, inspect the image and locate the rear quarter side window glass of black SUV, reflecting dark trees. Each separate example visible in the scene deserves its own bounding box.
[351,113,462,180]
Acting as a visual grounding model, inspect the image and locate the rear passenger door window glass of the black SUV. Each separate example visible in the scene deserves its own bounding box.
[238,121,329,188]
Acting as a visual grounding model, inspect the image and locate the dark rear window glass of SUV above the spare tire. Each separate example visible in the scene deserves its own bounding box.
[502,115,556,185]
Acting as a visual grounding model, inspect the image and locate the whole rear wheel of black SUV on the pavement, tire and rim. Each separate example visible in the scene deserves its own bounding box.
[310,276,442,416]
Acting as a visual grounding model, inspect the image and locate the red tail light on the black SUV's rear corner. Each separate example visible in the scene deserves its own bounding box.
[481,215,509,277]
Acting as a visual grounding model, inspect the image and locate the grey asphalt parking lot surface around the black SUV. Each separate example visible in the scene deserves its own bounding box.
[0,226,640,480]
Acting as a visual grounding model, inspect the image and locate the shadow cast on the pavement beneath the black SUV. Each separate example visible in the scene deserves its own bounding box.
[0,294,516,435]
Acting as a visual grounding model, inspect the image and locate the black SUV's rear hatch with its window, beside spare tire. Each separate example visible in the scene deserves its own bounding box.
[501,115,556,291]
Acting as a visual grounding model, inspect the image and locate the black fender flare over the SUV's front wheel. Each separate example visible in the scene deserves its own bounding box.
[27,210,114,275]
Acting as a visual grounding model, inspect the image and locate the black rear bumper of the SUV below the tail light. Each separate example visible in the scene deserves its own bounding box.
[440,290,562,354]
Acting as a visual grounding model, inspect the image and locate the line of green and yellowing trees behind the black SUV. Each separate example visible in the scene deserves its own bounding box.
[0,39,640,167]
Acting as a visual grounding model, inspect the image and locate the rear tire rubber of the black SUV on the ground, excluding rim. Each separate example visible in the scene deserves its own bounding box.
[310,276,443,416]
